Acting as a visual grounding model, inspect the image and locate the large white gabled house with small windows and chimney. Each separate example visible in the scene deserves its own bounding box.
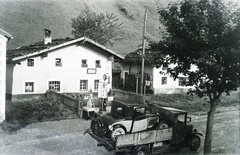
[7,37,123,100]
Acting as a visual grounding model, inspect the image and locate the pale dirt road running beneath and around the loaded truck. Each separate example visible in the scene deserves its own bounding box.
[0,111,240,155]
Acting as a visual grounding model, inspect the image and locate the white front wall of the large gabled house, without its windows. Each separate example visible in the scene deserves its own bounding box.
[9,44,112,95]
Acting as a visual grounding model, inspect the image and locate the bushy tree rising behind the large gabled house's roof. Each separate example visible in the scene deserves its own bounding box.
[72,7,122,45]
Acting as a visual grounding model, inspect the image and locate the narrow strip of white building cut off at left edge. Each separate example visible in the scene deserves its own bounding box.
[0,29,12,122]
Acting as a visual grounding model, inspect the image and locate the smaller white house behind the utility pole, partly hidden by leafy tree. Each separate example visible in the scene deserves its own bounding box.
[121,50,196,94]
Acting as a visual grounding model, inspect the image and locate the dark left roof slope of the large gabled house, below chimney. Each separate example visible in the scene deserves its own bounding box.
[7,38,73,60]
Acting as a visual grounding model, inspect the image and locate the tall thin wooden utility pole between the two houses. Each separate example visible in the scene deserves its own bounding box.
[141,10,147,95]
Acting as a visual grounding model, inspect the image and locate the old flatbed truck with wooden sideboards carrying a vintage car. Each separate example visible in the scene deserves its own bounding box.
[85,100,202,155]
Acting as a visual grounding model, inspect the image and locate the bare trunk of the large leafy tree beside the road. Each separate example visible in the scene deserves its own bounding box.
[204,101,217,155]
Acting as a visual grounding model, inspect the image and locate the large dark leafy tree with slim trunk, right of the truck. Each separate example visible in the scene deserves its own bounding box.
[151,0,240,154]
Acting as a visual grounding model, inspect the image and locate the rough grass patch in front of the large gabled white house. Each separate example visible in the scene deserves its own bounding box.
[0,98,78,132]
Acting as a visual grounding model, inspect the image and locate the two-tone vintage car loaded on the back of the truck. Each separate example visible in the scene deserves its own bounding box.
[91,100,168,139]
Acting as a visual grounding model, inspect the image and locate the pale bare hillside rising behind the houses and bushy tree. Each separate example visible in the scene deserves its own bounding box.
[0,0,167,55]
